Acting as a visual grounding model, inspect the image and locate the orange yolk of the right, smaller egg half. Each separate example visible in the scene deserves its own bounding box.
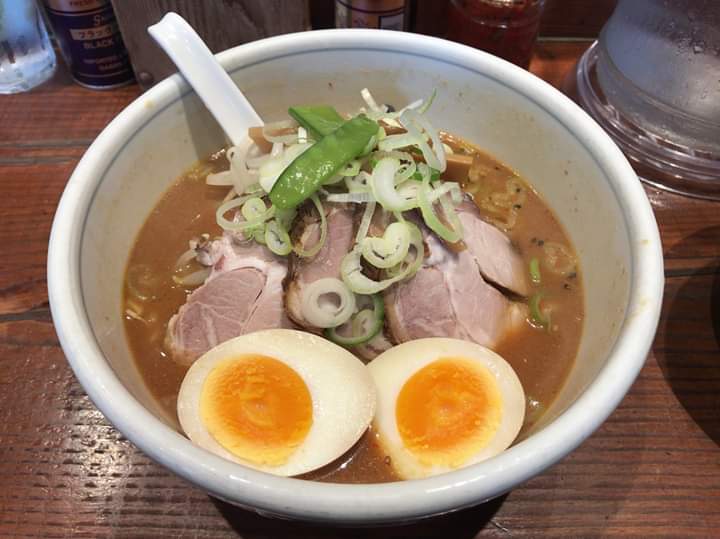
[395,358,502,468]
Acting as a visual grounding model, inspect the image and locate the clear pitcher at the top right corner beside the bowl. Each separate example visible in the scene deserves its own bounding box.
[576,0,720,200]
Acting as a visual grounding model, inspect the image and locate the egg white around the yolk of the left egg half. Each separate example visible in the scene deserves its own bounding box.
[177,329,376,476]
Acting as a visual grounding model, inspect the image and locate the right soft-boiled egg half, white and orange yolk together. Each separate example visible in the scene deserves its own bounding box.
[368,338,525,479]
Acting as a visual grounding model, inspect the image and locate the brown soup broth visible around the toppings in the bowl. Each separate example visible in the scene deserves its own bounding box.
[124,141,584,483]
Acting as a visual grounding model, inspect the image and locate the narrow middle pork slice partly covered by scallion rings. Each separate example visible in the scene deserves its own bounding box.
[285,202,355,331]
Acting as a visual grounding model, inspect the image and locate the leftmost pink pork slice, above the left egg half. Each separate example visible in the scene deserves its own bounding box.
[165,233,293,365]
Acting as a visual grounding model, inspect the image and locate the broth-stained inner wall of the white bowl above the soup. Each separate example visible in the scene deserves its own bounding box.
[81,45,630,429]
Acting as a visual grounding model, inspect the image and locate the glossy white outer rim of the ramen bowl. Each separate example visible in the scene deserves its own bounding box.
[47,30,664,524]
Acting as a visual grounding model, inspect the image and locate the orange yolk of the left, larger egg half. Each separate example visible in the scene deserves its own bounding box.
[200,355,313,466]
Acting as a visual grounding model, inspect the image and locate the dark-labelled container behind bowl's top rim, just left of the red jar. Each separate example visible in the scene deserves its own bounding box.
[335,0,405,30]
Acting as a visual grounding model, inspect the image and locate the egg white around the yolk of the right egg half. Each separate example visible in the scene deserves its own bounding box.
[368,338,525,479]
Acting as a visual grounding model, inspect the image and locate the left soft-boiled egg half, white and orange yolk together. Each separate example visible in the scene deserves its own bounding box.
[178,329,376,476]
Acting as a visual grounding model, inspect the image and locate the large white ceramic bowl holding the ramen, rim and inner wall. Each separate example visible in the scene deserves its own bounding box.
[48,30,663,524]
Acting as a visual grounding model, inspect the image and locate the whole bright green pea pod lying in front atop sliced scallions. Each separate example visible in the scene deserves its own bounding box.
[270,114,378,209]
